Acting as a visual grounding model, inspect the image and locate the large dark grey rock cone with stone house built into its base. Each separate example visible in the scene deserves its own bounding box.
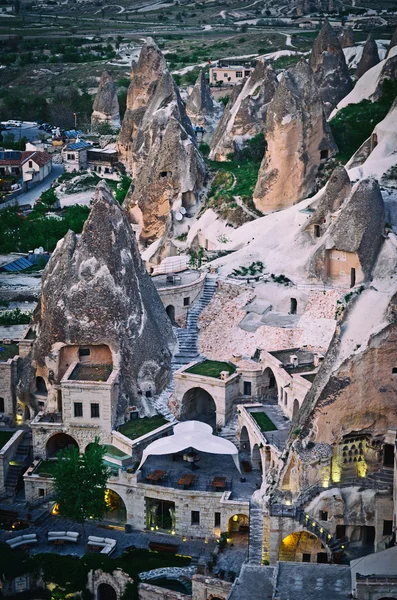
[23,182,174,423]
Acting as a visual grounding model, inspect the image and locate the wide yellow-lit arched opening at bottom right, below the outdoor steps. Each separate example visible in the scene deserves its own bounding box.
[278,531,328,563]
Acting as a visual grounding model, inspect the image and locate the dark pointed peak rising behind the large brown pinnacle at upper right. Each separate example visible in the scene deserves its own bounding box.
[309,21,352,116]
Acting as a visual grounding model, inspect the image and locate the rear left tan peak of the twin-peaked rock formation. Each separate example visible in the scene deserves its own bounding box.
[118,38,167,173]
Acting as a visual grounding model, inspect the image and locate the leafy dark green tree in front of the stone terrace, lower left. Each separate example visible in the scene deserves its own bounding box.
[54,437,110,547]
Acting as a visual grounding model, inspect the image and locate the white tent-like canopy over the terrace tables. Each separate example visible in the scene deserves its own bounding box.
[138,421,241,473]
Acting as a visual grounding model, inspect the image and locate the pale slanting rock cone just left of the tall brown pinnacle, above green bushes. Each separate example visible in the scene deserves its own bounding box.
[210,60,277,161]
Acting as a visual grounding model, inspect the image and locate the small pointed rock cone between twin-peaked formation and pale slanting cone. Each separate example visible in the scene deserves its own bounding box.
[186,71,223,142]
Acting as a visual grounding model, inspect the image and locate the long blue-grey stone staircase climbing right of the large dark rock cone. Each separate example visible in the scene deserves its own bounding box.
[153,276,216,423]
